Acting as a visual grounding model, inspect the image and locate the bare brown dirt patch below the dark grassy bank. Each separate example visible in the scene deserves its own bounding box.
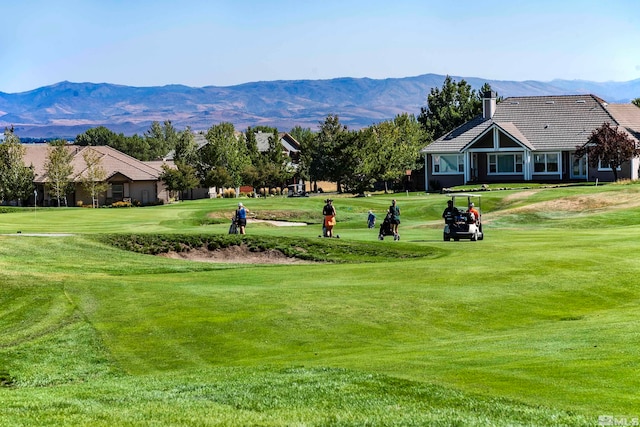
[159,245,311,264]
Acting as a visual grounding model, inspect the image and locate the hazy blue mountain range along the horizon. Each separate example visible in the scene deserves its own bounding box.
[0,74,640,138]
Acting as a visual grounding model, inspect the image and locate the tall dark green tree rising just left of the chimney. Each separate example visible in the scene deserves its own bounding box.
[418,76,482,140]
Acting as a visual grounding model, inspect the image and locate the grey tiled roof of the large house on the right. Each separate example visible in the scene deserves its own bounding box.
[422,95,640,153]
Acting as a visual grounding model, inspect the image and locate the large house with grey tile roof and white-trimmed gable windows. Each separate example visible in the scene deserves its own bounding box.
[421,91,640,190]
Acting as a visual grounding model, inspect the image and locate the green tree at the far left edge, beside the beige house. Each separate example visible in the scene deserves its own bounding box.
[0,128,35,204]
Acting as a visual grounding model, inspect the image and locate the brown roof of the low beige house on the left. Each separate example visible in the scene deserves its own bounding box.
[24,144,168,183]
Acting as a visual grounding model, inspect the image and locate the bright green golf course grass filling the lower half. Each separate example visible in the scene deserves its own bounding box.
[0,183,640,426]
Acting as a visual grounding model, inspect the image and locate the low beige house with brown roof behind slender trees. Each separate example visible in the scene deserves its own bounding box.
[24,144,169,206]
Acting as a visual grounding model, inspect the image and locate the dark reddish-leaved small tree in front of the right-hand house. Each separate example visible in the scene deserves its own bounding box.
[575,122,640,181]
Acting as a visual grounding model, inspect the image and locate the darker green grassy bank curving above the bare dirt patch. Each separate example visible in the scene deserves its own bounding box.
[98,234,445,263]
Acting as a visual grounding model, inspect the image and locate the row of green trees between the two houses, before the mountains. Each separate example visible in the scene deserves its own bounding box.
[70,77,491,197]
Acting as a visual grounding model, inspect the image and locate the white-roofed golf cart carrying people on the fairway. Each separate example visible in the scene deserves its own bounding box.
[443,193,484,242]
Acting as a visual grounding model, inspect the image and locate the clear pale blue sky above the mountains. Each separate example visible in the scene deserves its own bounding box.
[0,0,640,93]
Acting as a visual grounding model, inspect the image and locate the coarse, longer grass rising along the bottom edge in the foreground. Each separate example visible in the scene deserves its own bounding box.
[0,367,593,426]
